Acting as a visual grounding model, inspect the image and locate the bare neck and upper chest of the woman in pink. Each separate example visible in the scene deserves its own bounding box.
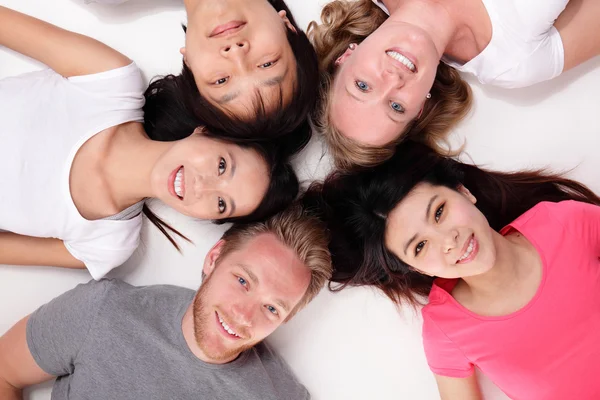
[462,232,527,298]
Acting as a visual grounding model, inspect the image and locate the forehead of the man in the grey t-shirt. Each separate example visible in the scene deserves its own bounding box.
[225,233,311,303]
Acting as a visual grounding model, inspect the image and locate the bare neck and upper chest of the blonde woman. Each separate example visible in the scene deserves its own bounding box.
[386,0,464,58]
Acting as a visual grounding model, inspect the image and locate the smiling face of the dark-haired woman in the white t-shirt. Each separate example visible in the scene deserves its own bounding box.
[151,130,269,219]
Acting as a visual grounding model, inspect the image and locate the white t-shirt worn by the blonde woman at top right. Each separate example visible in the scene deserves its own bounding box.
[373,0,569,88]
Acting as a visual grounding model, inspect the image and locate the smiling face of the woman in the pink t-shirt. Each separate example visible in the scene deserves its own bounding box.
[385,183,496,279]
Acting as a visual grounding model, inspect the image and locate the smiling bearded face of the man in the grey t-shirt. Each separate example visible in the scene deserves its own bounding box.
[193,233,311,363]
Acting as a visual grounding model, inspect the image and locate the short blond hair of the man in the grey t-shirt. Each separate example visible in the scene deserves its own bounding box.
[217,203,332,319]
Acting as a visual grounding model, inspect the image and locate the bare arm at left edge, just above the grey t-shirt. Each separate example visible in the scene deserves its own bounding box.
[0,232,85,268]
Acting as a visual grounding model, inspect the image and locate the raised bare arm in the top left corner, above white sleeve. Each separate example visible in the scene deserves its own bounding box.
[0,6,131,77]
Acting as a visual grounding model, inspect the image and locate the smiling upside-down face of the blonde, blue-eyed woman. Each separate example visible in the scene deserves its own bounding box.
[330,19,440,146]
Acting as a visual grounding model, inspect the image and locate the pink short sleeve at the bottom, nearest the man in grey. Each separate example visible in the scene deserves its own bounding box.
[423,313,474,378]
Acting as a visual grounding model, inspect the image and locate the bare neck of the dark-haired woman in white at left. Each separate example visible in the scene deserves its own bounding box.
[102,123,172,210]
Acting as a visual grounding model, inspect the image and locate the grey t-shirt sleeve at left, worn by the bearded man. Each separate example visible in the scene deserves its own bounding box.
[27,280,111,376]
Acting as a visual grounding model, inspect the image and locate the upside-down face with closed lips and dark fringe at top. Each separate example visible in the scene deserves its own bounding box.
[182,0,296,118]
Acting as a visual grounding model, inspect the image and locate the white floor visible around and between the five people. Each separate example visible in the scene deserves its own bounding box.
[0,0,600,400]
